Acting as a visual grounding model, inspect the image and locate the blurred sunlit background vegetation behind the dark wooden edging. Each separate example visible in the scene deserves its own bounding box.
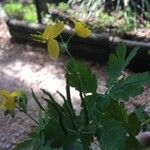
[4,0,150,33]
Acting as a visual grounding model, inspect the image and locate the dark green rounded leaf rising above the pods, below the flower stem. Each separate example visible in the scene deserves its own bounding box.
[67,60,97,93]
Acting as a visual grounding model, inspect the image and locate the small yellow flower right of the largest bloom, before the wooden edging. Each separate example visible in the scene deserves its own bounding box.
[72,20,91,38]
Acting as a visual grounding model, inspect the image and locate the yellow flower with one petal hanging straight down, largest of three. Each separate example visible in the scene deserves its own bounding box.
[32,22,64,60]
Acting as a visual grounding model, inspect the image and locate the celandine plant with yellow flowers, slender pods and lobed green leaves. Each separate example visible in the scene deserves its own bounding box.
[0,20,150,150]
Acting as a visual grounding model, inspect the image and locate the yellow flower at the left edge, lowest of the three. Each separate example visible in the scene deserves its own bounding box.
[0,90,20,110]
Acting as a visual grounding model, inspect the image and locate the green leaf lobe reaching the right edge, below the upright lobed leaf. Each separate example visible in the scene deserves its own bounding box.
[110,72,150,100]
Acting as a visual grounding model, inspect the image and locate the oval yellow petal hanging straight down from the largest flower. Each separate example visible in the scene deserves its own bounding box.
[47,39,59,60]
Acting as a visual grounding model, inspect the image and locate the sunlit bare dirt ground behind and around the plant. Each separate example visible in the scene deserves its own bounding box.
[0,15,150,150]
